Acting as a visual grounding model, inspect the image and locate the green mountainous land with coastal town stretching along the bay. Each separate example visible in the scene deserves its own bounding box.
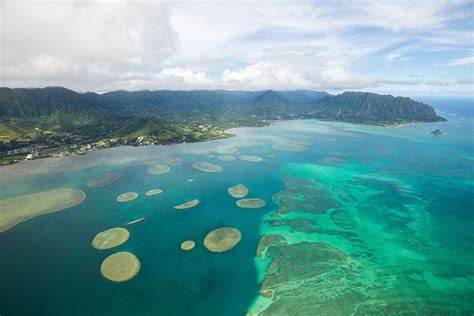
[0,87,446,165]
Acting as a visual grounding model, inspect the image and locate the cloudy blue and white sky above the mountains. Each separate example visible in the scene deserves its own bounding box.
[0,0,474,96]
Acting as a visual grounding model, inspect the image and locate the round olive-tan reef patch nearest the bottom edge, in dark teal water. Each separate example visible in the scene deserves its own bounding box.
[100,251,140,282]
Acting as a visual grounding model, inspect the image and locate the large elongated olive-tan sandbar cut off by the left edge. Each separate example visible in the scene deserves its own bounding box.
[0,189,86,232]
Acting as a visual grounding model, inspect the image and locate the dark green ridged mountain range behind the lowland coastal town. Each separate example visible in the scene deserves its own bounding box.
[0,88,445,124]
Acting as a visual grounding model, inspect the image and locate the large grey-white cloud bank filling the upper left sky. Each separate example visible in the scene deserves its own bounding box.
[0,0,177,89]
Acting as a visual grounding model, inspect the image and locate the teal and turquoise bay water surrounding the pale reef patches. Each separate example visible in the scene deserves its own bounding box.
[0,99,474,315]
